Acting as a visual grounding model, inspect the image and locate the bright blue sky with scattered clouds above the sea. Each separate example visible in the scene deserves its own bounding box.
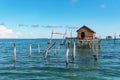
[0,0,120,38]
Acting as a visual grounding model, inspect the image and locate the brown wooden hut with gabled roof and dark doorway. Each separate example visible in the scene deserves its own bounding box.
[77,25,96,40]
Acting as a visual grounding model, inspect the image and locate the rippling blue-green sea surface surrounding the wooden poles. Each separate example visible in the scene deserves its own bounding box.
[0,39,120,80]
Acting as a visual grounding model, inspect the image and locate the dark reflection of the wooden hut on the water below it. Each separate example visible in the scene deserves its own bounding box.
[76,49,98,67]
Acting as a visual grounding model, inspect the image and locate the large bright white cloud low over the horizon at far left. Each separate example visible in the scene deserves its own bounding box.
[0,25,21,38]
